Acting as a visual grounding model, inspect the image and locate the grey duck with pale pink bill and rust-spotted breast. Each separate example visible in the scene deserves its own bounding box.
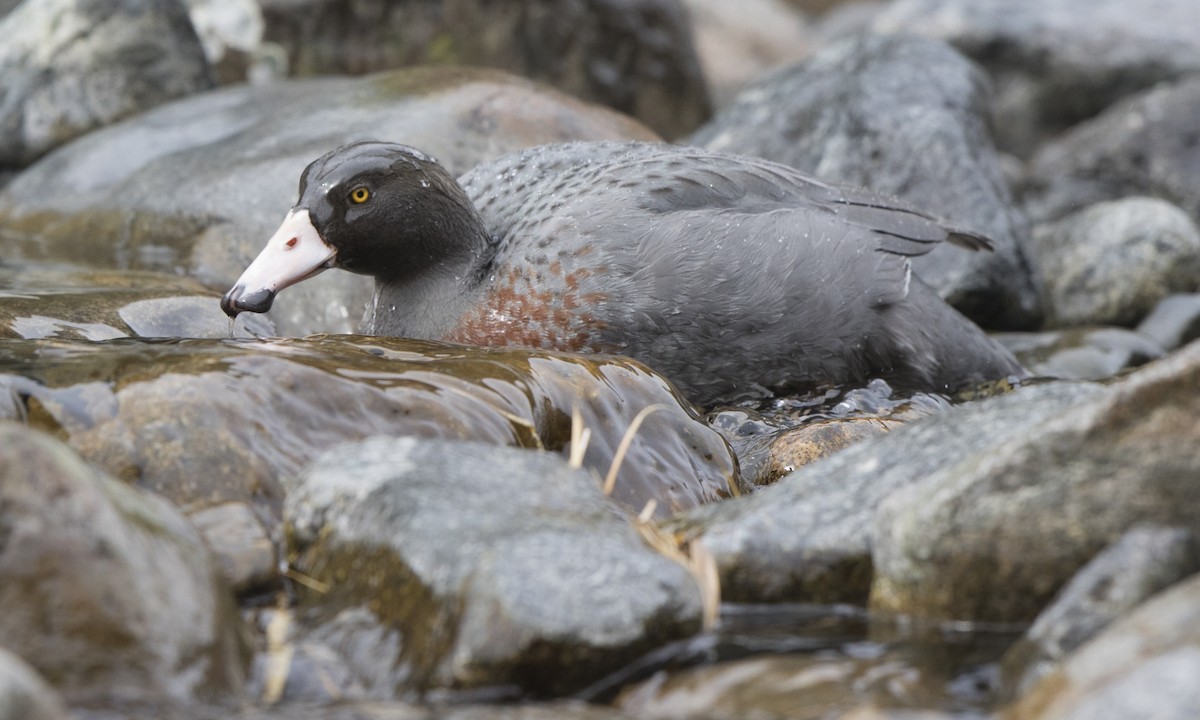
[221,142,1024,404]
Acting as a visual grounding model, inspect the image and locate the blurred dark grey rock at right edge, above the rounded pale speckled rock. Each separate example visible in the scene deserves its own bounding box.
[1022,77,1200,223]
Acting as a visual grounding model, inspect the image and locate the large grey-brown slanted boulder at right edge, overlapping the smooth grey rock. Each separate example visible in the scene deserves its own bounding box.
[871,343,1200,622]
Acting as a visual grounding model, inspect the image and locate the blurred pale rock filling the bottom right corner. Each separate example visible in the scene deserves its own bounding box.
[1002,576,1200,720]
